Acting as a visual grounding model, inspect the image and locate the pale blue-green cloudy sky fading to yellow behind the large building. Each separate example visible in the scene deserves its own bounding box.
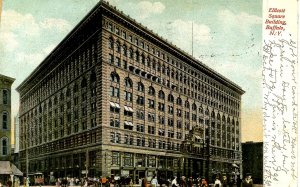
[0,0,263,142]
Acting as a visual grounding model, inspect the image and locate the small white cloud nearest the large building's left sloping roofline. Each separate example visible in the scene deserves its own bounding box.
[40,18,72,32]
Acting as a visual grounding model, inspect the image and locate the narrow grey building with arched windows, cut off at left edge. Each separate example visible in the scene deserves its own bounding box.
[0,75,15,161]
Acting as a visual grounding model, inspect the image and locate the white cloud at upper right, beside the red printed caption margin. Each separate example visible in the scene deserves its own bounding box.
[218,10,262,34]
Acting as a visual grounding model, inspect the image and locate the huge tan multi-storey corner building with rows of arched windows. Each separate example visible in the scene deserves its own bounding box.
[17,1,244,182]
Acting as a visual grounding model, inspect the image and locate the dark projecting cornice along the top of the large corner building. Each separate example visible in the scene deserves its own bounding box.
[17,0,245,94]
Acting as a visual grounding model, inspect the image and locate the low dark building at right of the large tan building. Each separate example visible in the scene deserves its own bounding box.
[242,142,263,184]
